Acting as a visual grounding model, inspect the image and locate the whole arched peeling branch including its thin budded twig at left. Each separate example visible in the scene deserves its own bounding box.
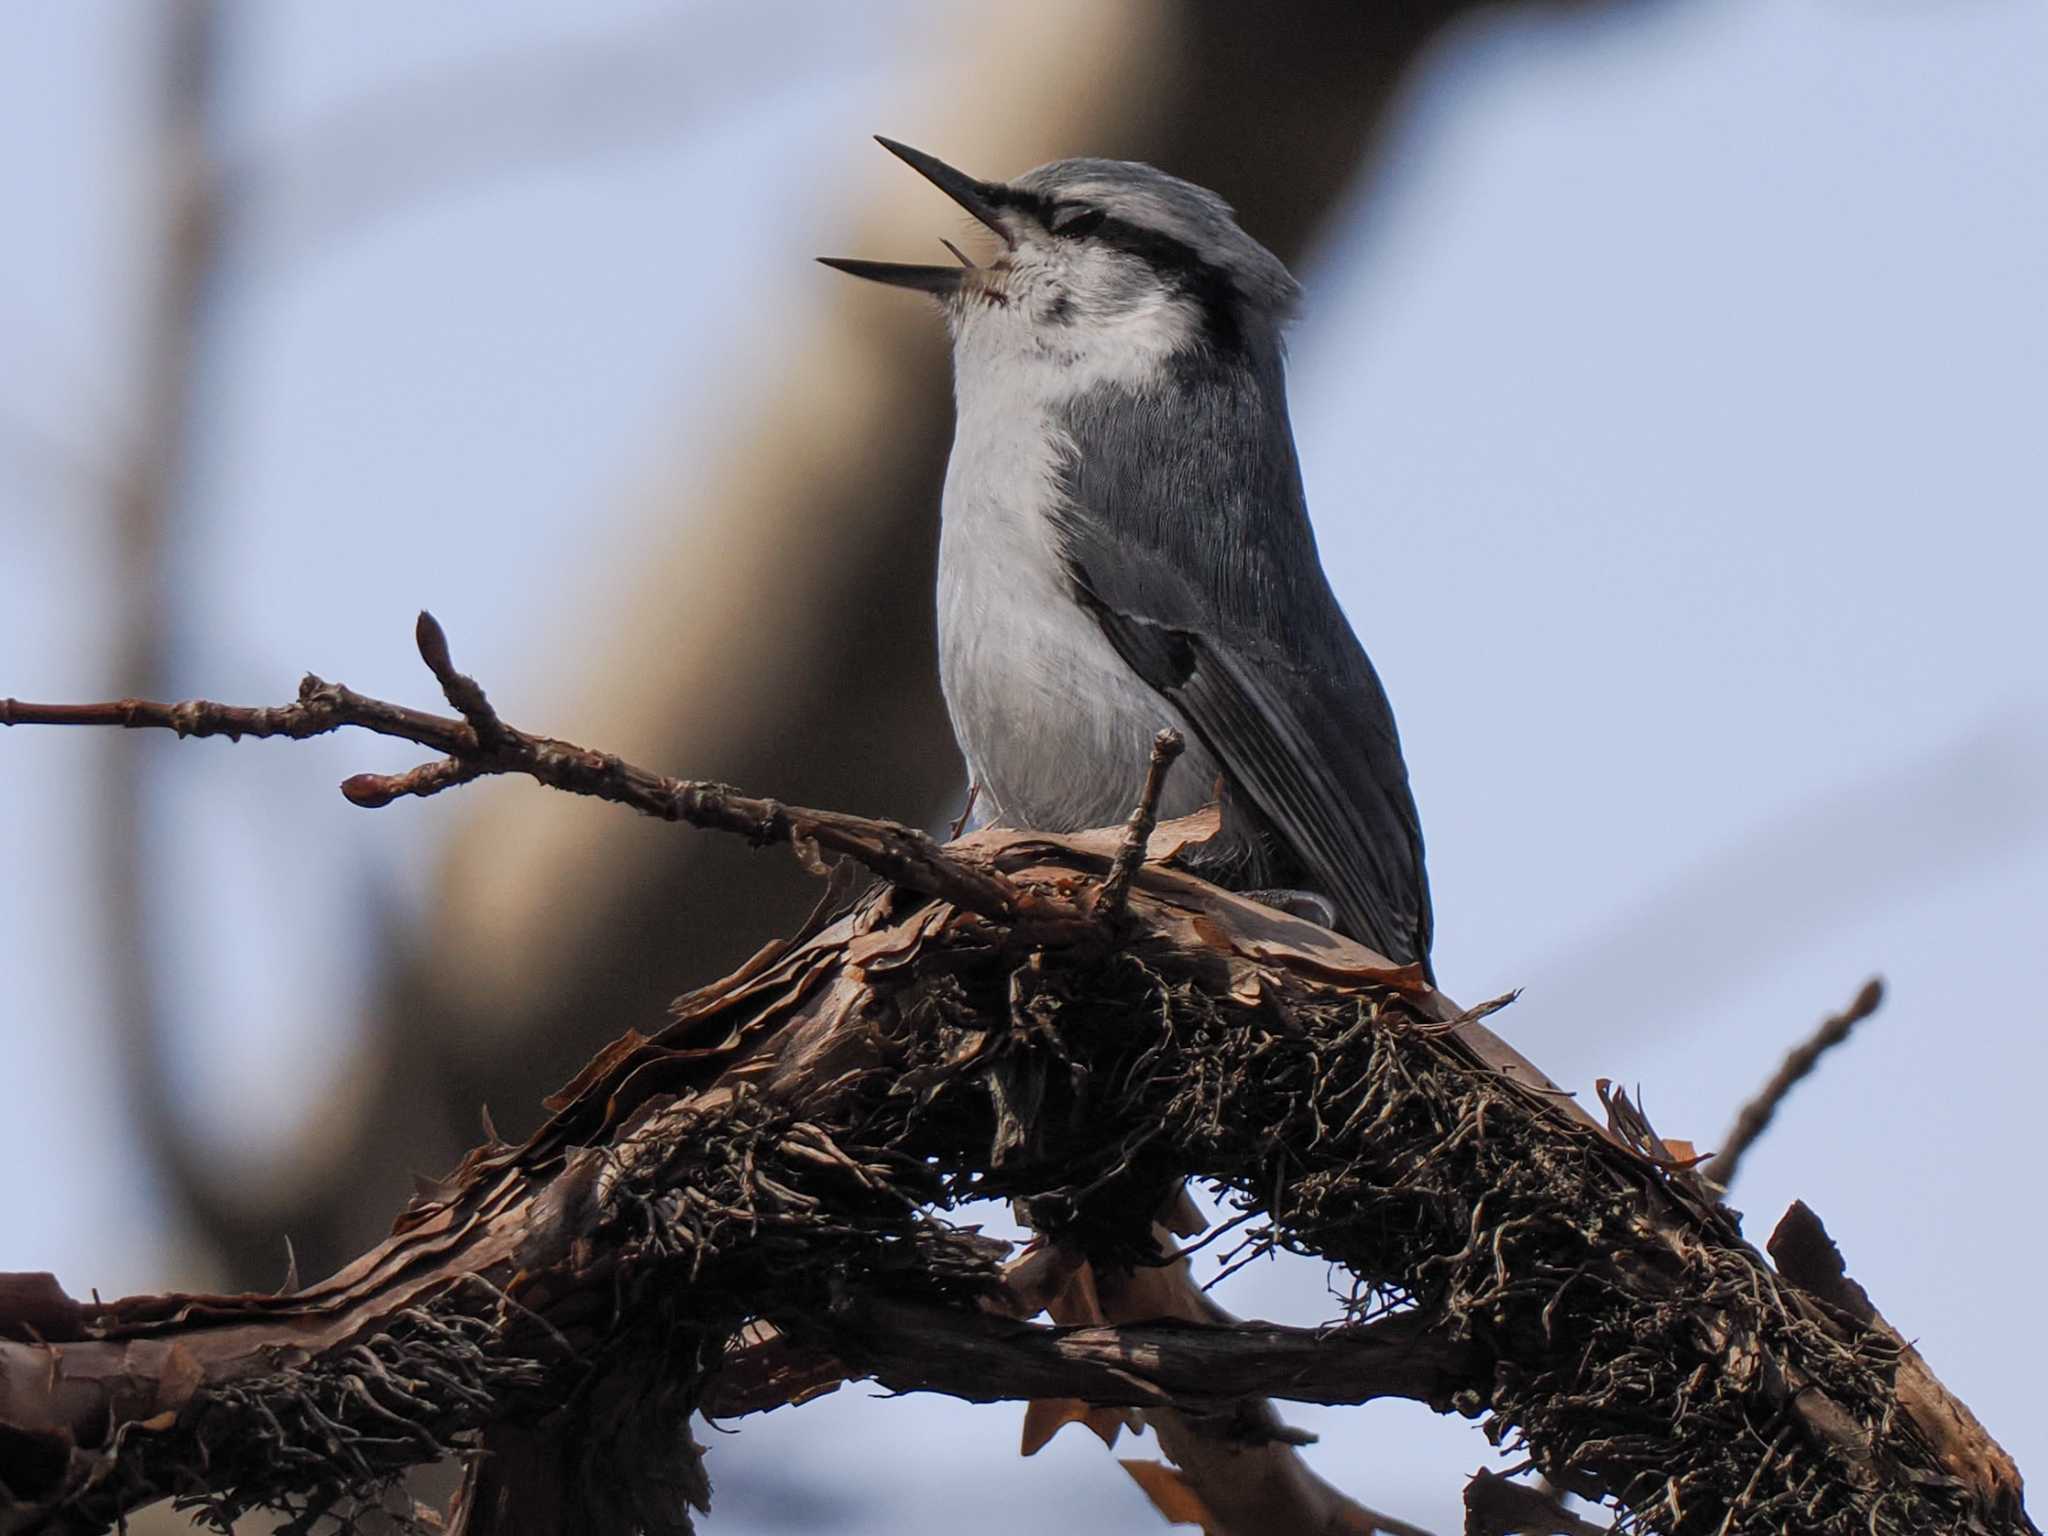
[0,625,2034,1536]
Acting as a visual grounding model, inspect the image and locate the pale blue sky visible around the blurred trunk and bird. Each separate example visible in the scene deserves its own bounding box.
[0,0,2048,1536]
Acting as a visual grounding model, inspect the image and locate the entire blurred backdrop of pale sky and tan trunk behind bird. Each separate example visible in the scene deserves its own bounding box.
[0,0,2048,1536]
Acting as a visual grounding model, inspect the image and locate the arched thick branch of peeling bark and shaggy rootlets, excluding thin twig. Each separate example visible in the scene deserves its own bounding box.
[0,834,2032,1536]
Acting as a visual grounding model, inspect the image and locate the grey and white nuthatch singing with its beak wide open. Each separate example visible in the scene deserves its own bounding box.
[819,135,1434,977]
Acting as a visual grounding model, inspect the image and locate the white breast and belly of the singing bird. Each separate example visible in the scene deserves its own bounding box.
[938,292,1217,831]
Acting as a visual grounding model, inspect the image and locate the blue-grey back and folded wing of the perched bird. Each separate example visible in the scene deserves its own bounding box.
[1061,354,1432,967]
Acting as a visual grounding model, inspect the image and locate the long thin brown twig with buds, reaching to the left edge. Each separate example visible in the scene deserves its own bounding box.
[0,614,1040,930]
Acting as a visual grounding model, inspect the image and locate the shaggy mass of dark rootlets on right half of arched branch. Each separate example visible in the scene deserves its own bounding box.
[856,925,1995,1532]
